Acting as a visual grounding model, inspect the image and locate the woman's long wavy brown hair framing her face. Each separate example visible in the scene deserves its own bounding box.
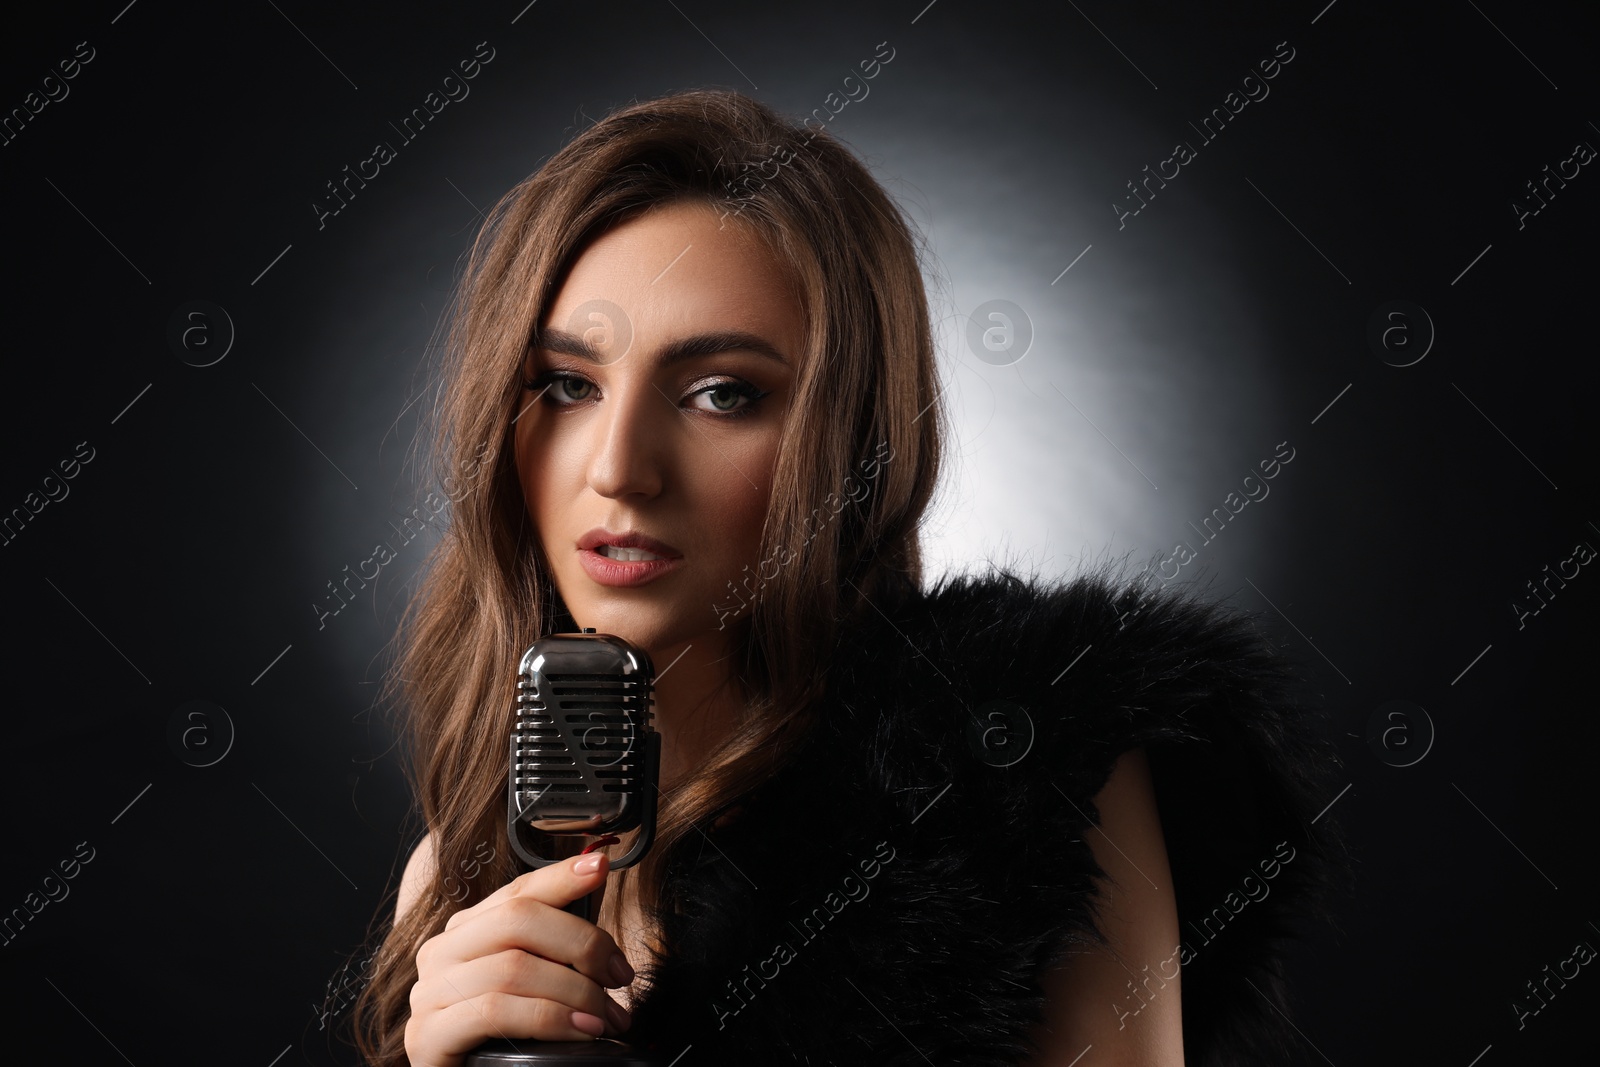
[354,90,946,1067]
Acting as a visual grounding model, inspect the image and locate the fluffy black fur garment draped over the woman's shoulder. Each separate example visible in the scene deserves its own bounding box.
[627,571,1342,1067]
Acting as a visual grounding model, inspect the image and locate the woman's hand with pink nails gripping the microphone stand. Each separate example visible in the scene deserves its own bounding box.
[405,853,634,1067]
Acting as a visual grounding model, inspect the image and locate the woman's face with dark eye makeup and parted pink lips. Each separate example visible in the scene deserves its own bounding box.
[515,195,805,655]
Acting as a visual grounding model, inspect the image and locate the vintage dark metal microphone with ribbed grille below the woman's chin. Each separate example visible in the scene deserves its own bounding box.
[464,627,666,1067]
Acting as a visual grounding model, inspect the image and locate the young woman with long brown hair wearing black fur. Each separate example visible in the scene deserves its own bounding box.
[355,91,1333,1067]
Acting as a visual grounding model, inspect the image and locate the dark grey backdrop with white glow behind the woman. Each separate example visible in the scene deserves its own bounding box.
[0,0,1600,1067]
